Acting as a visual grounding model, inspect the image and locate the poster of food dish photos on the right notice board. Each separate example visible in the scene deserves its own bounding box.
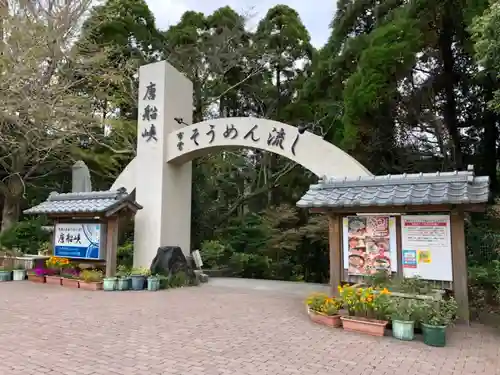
[343,215,397,276]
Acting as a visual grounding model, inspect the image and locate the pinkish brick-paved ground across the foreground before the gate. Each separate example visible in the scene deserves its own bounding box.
[0,280,500,375]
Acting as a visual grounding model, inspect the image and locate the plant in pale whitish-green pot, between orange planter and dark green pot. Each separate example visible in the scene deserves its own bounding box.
[391,298,418,341]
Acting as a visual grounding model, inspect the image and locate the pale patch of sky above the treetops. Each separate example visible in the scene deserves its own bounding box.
[146,0,336,47]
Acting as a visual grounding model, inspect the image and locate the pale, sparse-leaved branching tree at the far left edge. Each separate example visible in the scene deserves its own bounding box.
[0,0,127,231]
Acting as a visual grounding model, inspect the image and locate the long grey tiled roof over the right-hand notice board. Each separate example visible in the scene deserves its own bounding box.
[297,166,490,208]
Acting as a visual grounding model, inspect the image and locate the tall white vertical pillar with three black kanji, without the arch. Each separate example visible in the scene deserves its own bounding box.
[134,61,193,267]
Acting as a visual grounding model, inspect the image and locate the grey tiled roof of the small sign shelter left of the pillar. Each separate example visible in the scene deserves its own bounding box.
[24,189,142,214]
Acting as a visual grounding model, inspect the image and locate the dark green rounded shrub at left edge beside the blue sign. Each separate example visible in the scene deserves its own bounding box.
[0,218,51,254]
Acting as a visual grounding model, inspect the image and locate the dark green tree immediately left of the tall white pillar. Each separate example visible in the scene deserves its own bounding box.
[75,0,164,189]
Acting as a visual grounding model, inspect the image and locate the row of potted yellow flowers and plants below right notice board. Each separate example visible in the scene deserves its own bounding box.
[306,285,457,346]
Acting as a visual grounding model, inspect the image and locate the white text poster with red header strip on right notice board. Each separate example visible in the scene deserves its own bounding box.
[401,215,453,281]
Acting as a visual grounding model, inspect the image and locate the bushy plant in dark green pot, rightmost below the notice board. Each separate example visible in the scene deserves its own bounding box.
[421,297,458,347]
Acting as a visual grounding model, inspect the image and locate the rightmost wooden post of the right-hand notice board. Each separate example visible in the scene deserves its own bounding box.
[450,211,470,324]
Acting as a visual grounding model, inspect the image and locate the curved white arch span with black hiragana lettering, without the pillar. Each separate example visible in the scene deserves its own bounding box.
[166,117,371,177]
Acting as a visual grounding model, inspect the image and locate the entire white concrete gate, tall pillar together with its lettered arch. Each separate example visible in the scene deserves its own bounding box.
[111,61,371,267]
